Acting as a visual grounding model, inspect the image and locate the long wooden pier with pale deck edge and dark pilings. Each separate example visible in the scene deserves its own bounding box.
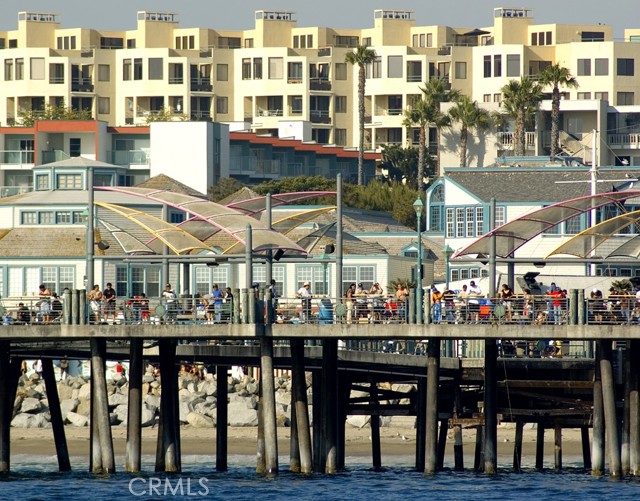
[0,314,640,478]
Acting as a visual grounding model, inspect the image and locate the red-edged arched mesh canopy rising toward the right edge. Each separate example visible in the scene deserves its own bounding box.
[453,190,640,258]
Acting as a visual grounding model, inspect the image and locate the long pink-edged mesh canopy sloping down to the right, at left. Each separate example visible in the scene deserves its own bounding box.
[96,186,306,254]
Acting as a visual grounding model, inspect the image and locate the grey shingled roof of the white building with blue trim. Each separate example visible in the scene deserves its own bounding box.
[445,167,632,204]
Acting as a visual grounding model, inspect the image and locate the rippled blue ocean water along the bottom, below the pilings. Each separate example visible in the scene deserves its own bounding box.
[0,455,640,501]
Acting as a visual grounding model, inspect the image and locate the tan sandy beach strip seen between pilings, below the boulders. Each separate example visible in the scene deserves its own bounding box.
[11,425,582,458]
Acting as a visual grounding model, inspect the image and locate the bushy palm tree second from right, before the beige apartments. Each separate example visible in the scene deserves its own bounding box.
[500,77,542,156]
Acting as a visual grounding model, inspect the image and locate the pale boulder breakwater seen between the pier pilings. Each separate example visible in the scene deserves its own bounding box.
[11,366,311,428]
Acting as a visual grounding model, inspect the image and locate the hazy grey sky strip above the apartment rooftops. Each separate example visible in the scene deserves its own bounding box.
[0,0,640,38]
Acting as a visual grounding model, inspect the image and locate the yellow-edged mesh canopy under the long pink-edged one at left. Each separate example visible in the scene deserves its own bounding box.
[95,202,213,254]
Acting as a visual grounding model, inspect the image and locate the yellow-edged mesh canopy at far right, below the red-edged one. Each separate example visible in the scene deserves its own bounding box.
[547,210,640,258]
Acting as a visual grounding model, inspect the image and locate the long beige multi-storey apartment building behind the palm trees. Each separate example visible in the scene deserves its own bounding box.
[0,7,640,166]
